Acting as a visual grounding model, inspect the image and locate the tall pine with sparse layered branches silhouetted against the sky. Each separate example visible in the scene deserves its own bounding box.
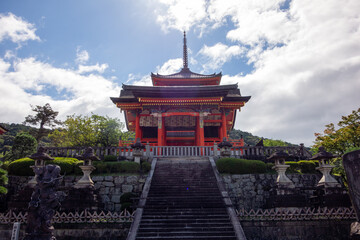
[24,103,61,142]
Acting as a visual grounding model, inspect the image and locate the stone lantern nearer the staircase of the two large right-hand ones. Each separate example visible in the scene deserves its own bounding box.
[268,151,295,195]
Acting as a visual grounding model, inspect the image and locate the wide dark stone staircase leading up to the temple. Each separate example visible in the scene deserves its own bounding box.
[136,159,243,240]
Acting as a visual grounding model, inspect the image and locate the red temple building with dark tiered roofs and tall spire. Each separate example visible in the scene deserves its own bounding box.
[111,32,250,146]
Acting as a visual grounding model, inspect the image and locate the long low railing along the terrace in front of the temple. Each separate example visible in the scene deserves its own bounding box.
[46,144,312,160]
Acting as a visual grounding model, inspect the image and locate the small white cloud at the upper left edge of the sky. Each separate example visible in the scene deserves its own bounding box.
[0,13,40,43]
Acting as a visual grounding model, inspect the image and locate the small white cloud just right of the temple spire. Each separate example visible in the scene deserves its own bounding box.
[199,43,244,71]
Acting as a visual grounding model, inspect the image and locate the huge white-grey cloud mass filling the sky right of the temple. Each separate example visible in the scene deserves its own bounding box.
[155,0,360,145]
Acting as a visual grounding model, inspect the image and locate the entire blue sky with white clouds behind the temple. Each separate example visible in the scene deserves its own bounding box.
[0,0,360,145]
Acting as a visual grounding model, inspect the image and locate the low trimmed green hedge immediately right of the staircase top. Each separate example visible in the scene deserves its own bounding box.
[216,158,267,174]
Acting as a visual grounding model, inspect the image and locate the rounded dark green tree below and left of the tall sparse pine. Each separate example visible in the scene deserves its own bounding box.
[11,133,37,160]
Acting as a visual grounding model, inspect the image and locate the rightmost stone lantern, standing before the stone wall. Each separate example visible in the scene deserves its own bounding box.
[311,147,341,188]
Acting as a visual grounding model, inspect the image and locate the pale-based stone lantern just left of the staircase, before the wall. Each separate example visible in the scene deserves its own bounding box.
[74,147,100,188]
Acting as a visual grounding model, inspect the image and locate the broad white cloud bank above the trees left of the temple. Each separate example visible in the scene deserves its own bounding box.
[0,55,121,123]
